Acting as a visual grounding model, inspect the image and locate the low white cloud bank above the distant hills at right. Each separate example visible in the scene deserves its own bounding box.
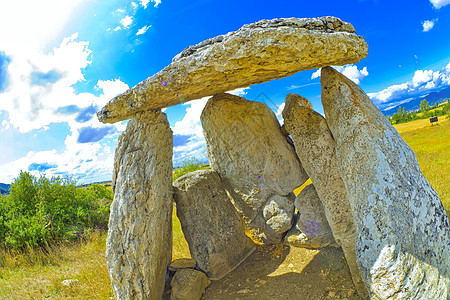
[368,63,450,104]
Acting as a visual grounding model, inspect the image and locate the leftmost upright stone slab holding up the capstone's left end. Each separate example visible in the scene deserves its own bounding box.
[106,111,173,300]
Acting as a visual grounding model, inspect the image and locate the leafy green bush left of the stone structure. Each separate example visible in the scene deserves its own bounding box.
[0,172,113,250]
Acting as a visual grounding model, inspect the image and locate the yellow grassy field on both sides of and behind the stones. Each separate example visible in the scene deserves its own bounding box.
[0,117,450,299]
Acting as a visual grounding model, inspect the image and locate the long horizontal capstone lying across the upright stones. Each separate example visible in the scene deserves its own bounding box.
[97,17,367,123]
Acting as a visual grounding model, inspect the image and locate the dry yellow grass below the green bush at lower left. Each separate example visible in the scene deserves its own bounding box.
[0,233,113,299]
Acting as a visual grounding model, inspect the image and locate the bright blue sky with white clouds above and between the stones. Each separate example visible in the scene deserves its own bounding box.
[0,0,450,183]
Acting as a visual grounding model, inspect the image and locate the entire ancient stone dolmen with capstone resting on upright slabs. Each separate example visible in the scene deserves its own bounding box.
[97,17,450,300]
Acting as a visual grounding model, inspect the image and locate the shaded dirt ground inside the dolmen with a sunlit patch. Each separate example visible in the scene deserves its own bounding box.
[202,245,360,300]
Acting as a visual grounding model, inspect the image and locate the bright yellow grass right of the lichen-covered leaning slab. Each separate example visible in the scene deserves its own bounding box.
[394,116,450,216]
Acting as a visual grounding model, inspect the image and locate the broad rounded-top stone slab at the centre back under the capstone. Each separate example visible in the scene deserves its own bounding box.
[200,94,308,243]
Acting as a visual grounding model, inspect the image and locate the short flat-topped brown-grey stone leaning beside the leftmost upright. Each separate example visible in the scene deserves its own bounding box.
[173,170,255,280]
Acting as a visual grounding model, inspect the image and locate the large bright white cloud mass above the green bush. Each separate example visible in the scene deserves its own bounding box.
[0,8,128,182]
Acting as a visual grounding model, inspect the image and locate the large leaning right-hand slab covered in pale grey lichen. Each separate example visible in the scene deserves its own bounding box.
[321,67,450,299]
